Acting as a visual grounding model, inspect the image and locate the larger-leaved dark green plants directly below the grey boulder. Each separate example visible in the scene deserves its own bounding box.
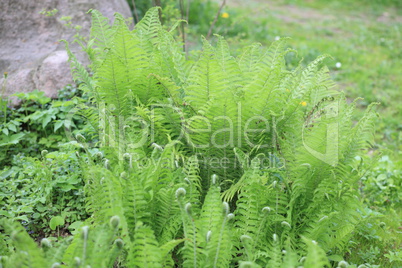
[0,86,84,166]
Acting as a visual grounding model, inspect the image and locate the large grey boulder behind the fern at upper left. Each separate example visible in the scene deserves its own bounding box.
[0,0,131,104]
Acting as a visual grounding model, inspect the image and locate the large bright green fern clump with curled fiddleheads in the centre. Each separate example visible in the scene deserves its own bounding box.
[0,8,376,267]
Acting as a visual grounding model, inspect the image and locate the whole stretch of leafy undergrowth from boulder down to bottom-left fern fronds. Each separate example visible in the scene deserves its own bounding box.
[0,86,92,239]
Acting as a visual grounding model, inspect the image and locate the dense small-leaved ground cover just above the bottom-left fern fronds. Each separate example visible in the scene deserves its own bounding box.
[0,144,88,238]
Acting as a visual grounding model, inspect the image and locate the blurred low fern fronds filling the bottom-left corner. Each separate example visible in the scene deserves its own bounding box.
[0,219,124,267]
